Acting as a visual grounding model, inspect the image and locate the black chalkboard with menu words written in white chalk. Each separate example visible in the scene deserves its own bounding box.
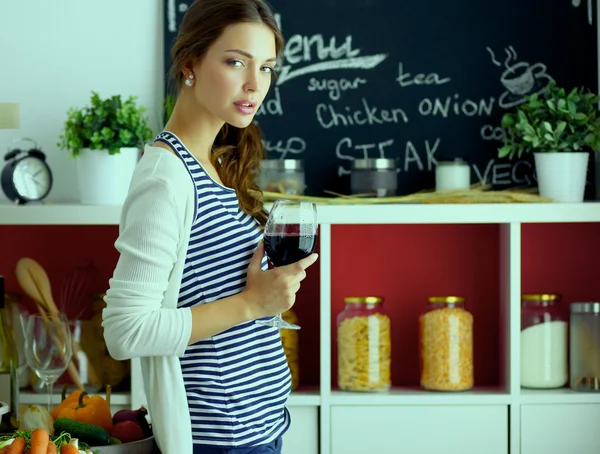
[165,0,598,196]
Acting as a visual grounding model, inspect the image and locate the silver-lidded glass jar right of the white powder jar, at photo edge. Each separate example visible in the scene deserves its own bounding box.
[570,302,600,391]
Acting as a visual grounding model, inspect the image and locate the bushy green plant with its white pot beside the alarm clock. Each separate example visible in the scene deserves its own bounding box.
[57,91,152,205]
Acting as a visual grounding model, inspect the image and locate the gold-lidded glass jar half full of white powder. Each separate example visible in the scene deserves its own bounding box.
[521,293,569,389]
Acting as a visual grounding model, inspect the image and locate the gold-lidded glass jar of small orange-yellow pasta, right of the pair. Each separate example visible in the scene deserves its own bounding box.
[419,296,474,391]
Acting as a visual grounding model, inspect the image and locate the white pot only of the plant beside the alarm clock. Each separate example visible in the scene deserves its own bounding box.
[76,148,140,205]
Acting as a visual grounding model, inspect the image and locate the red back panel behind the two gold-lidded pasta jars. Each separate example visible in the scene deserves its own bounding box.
[331,225,500,386]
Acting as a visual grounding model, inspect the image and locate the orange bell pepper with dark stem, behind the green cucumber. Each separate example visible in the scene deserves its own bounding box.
[52,391,113,430]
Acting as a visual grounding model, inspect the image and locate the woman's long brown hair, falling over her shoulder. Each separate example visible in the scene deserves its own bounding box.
[169,0,284,225]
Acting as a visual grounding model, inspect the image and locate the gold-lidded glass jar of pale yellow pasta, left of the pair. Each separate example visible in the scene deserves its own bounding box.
[337,296,392,391]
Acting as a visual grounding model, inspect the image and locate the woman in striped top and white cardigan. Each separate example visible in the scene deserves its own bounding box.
[103,0,317,454]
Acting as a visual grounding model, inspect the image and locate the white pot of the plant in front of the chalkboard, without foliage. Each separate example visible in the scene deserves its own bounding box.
[534,152,590,203]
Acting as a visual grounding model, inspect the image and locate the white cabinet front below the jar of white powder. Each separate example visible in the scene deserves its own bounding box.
[521,404,600,454]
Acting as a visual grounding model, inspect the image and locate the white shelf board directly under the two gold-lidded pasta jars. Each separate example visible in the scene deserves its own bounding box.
[331,388,511,405]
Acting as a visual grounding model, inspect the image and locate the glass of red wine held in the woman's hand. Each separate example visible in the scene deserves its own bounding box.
[256,200,317,329]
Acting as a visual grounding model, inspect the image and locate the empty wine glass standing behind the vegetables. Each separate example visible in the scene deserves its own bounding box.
[25,314,73,411]
